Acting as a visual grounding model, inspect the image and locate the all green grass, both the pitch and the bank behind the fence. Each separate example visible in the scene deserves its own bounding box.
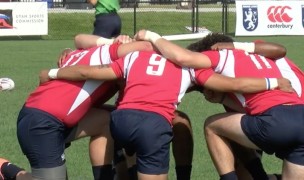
[0,8,304,180]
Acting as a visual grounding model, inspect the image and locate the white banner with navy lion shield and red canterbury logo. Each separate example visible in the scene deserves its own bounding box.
[235,0,304,36]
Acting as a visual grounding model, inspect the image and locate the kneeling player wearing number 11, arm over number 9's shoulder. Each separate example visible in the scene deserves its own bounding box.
[138,31,304,180]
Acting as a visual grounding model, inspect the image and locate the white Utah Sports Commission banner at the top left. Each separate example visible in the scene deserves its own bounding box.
[0,2,48,36]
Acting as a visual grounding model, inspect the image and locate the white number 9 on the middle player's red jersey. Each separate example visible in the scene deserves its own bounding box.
[146,54,167,76]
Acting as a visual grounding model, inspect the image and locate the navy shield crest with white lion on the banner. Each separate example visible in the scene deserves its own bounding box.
[242,5,258,31]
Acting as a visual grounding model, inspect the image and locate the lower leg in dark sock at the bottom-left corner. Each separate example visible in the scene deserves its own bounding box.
[0,158,32,180]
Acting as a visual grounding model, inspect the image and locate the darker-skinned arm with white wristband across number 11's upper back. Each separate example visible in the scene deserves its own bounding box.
[211,42,286,59]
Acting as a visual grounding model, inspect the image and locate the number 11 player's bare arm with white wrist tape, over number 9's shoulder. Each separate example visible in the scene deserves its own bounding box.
[134,30,211,68]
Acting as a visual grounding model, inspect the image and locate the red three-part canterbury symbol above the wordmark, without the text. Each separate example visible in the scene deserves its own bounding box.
[267,6,292,22]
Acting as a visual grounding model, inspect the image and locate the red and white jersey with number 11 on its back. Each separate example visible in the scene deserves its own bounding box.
[195,50,303,115]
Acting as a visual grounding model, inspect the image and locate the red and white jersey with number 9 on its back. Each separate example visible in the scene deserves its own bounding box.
[111,51,191,124]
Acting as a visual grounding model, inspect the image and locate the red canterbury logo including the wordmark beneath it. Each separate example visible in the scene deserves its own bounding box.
[267,6,293,29]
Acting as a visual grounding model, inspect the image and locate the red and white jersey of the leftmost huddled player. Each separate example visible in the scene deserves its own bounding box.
[25,44,118,127]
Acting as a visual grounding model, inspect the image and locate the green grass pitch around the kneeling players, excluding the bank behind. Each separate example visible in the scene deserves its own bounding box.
[0,36,304,180]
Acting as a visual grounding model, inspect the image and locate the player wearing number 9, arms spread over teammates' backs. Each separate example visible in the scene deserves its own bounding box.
[40,37,291,180]
